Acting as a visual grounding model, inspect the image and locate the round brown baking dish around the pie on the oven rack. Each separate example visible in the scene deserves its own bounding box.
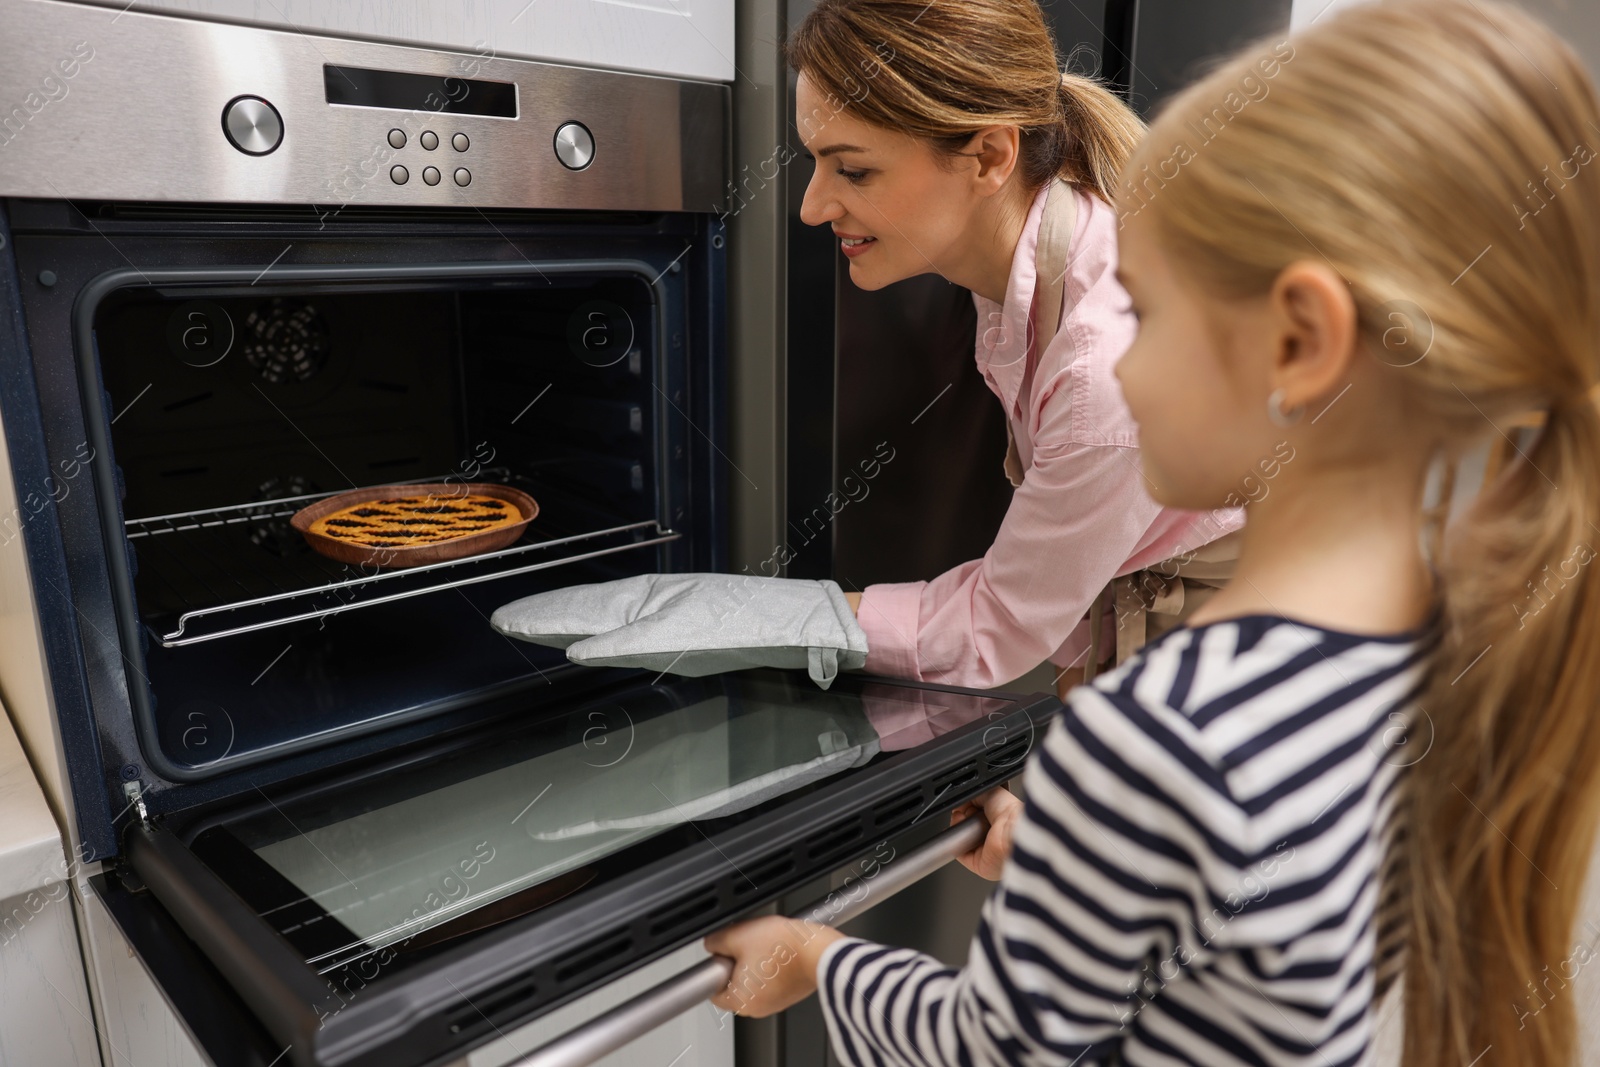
[290,482,539,568]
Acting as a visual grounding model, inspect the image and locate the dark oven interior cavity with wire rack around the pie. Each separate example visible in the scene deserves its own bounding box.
[86,269,709,777]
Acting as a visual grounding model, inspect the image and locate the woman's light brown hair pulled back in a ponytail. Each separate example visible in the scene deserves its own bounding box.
[787,0,1144,202]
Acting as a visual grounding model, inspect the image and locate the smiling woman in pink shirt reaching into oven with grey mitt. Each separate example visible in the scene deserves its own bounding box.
[494,0,1250,693]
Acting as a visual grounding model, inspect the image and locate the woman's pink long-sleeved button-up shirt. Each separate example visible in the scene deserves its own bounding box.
[858,181,1245,688]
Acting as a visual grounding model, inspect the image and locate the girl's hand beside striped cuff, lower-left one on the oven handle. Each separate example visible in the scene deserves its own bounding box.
[706,915,845,1019]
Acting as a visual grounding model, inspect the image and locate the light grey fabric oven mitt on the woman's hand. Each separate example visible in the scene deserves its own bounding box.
[490,574,867,689]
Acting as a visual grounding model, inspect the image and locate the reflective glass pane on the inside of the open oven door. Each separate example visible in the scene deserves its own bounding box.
[235,675,1005,969]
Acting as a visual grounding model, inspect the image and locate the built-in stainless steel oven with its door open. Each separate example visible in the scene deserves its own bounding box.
[0,0,1054,1065]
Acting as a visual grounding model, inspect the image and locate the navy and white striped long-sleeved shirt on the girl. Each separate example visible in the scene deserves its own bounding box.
[818,616,1438,1067]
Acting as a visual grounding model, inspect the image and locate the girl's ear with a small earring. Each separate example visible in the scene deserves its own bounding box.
[1270,259,1358,410]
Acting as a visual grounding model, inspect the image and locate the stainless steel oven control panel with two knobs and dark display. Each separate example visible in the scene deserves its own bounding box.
[0,0,730,213]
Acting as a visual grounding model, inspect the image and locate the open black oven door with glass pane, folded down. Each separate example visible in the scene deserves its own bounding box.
[94,670,1059,1067]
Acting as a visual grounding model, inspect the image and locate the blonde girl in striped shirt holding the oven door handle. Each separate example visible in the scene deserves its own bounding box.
[706,0,1600,1067]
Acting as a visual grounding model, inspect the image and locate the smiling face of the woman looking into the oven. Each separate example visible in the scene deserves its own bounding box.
[795,74,982,290]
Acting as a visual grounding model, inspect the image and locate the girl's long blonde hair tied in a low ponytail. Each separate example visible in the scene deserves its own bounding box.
[1118,0,1600,1067]
